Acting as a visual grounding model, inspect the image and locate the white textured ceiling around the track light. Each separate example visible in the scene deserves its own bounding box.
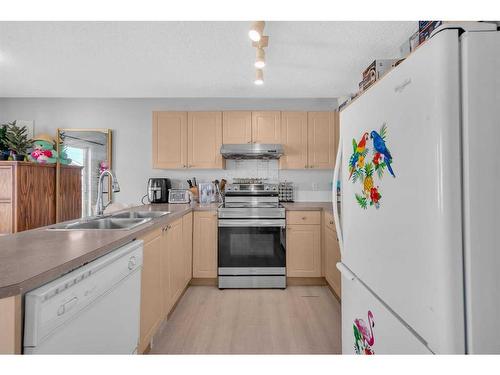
[0,21,416,98]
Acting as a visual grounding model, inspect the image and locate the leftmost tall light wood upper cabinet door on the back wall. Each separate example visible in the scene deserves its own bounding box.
[153,112,188,169]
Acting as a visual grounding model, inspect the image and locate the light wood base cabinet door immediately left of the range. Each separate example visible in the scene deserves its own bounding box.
[193,211,217,278]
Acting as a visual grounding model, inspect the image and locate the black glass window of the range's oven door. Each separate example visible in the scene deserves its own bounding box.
[219,227,286,267]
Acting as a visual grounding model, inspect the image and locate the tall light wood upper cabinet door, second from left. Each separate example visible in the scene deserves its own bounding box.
[187,112,223,168]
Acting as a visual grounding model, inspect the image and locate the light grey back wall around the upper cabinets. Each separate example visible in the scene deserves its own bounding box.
[0,98,337,204]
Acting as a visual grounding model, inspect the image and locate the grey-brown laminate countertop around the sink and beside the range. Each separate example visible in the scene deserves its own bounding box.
[0,202,332,298]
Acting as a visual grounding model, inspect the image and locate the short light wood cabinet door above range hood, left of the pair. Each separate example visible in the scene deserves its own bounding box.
[222,111,252,144]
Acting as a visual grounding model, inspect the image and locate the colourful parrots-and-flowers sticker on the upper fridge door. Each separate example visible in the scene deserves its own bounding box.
[348,123,396,209]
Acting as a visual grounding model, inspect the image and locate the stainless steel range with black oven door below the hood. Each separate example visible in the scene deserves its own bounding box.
[218,179,286,289]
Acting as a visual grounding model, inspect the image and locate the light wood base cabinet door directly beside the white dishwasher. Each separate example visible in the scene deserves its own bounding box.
[139,228,164,353]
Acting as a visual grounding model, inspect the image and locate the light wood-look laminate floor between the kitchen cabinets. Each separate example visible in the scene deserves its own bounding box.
[151,286,341,354]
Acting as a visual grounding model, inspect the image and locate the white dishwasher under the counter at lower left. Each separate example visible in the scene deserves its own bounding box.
[23,240,143,354]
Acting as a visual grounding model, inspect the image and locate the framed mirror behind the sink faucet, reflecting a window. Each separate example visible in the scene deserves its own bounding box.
[56,129,113,222]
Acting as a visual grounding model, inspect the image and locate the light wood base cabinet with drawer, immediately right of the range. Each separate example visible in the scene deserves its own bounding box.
[286,211,321,277]
